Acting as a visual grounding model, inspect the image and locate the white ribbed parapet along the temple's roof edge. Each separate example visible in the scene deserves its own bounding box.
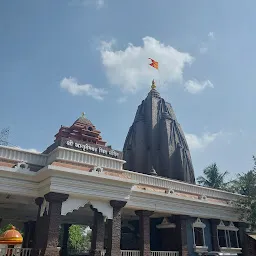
[0,146,244,205]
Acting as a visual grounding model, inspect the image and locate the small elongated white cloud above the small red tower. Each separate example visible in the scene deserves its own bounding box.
[60,77,107,100]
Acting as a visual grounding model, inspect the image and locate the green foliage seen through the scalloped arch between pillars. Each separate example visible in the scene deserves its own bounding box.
[68,225,91,251]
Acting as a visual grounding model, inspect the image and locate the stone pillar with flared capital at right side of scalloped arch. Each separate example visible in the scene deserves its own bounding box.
[107,200,127,256]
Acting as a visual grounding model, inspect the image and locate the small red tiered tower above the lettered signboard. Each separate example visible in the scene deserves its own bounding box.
[55,113,106,146]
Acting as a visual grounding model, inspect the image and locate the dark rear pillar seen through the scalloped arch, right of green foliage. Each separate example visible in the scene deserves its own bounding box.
[90,209,105,256]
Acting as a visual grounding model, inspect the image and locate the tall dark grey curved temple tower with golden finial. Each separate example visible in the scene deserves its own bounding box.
[123,80,195,183]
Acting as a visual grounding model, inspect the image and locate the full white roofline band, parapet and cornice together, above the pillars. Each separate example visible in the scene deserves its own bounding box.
[0,146,246,221]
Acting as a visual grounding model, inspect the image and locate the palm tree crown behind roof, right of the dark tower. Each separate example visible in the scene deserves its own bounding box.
[197,163,228,189]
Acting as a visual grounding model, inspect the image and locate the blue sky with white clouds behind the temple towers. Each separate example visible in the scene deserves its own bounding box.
[0,0,256,179]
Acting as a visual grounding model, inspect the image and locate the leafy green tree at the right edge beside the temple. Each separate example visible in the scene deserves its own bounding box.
[230,157,256,230]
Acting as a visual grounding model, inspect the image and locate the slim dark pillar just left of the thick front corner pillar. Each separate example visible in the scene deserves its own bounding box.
[33,197,44,255]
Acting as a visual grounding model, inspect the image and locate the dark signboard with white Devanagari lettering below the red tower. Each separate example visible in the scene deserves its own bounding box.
[65,140,122,158]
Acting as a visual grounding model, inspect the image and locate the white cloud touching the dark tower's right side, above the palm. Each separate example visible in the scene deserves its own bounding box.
[185,132,222,150]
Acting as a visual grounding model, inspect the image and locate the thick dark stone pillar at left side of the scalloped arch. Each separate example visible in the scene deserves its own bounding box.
[43,192,69,256]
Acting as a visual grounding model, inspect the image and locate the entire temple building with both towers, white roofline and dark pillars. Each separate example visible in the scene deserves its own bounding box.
[0,82,255,256]
